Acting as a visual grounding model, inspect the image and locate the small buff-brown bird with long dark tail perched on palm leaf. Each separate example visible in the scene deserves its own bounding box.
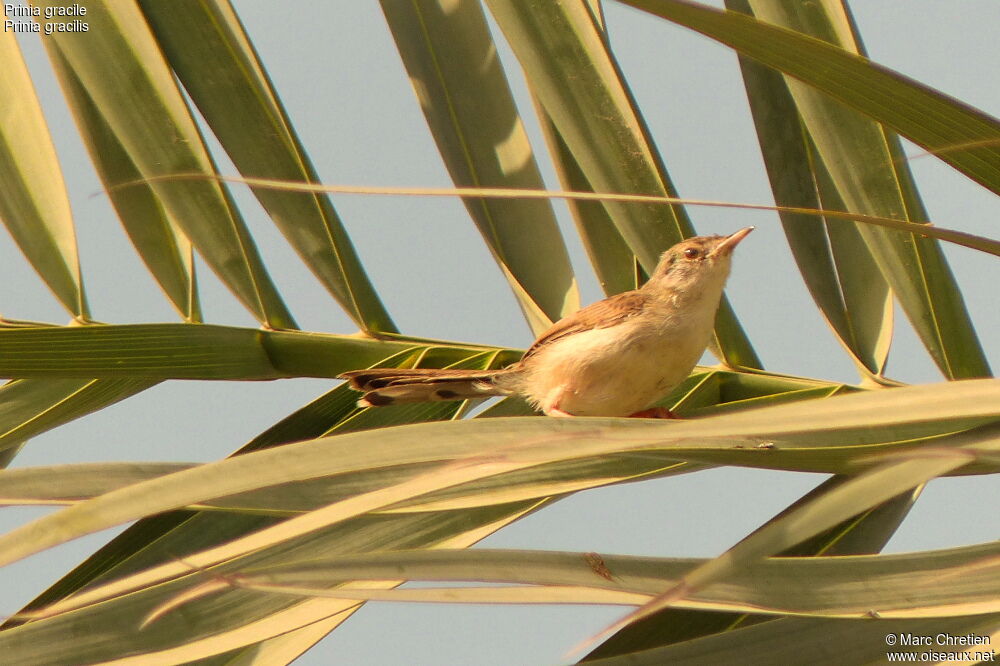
[340,227,753,418]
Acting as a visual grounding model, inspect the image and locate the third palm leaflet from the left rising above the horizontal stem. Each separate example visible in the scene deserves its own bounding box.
[38,0,295,328]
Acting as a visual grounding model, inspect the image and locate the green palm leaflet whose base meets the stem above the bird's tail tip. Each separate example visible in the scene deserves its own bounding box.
[139,0,396,332]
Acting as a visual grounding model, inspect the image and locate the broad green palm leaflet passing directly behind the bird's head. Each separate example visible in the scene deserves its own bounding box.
[487,0,760,367]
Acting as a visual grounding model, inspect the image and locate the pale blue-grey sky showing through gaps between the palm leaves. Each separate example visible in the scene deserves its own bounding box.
[0,0,1000,665]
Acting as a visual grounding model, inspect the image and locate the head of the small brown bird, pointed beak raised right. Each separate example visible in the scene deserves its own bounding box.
[646,227,753,291]
